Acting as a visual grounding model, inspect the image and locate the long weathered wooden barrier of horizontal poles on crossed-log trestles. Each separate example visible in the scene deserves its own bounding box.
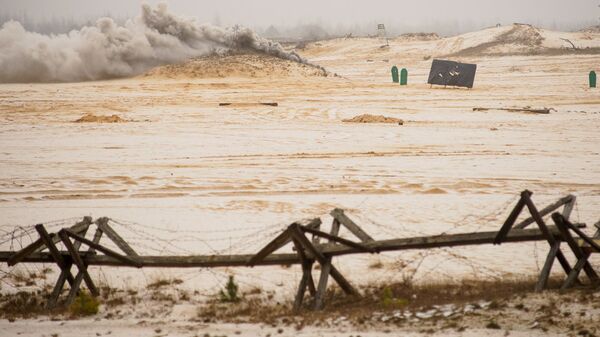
[0,191,600,310]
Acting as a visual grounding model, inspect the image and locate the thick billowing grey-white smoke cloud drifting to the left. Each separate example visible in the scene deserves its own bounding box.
[0,4,316,83]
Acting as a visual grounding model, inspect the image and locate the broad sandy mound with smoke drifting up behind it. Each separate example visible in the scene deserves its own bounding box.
[143,53,328,78]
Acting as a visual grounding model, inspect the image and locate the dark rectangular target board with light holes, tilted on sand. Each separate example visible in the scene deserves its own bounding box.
[427,60,477,88]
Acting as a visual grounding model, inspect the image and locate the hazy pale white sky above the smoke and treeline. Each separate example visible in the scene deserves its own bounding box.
[0,0,600,26]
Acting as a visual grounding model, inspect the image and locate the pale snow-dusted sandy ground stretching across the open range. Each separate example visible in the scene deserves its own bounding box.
[0,27,600,336]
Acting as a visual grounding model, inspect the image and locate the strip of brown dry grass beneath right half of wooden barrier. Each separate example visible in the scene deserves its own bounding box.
[199,277,562,324]
